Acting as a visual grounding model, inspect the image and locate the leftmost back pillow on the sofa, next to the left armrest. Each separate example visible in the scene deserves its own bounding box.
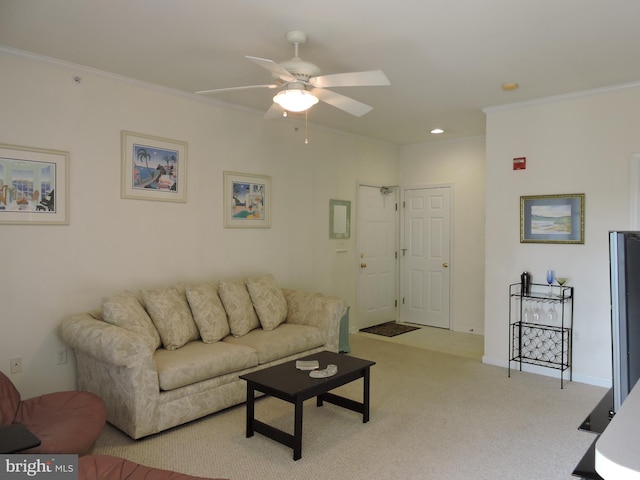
[102,292,162,350]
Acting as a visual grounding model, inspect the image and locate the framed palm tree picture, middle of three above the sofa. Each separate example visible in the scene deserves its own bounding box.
[121,131,187,202]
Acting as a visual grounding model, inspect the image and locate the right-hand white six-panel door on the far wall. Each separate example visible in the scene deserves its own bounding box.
[400,187,451,329]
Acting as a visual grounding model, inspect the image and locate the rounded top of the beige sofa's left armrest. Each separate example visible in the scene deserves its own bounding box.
[62,313,153,367]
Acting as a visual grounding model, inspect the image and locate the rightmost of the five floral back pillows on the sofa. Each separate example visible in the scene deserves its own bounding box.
[247,275,287,330]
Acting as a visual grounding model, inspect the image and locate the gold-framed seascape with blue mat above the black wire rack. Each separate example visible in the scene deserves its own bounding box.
[520,193,584,243]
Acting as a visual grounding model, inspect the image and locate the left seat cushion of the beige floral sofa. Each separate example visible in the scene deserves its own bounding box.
[153,342,258,390]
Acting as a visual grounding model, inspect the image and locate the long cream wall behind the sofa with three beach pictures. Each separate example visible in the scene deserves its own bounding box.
[0,50,398,397]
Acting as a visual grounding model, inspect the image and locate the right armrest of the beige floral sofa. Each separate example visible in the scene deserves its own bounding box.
[282,289,347,352]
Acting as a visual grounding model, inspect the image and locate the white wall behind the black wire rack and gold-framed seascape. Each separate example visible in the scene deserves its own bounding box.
[484,86,640,386]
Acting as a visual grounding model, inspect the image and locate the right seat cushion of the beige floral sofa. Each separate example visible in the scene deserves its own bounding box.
[222,323,327,365]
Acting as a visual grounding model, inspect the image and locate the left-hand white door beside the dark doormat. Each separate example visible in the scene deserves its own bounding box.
[357,185,398,328]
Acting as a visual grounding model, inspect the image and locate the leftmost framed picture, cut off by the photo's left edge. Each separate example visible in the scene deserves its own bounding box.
[0,144,69,225]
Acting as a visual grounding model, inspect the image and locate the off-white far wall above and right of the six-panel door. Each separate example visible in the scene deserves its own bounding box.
[399,137,485,334]
